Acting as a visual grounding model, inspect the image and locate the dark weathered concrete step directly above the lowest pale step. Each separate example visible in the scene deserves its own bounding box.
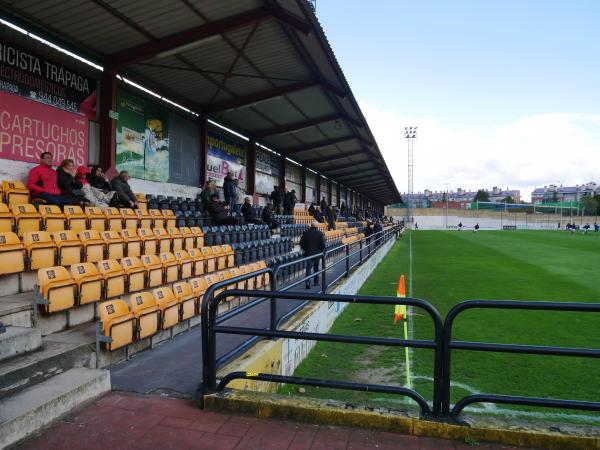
[0,325,96,399]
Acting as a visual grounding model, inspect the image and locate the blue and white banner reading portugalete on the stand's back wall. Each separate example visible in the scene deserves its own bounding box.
[206,130,246,190]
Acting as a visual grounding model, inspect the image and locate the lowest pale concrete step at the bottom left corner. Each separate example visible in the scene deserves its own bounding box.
[0,368,110,448]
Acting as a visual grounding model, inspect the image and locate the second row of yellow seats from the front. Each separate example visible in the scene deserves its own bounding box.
[38,247,247,313]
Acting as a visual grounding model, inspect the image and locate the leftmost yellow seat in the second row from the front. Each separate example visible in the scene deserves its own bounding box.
[38,266,77,313]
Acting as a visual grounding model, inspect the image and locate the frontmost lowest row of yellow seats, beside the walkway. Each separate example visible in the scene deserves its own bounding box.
[99,261,270,351]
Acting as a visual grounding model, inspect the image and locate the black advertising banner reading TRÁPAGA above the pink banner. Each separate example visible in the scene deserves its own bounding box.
[0,41,96,119]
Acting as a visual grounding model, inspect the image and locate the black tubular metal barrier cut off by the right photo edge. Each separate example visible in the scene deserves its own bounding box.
[442,300,600,418]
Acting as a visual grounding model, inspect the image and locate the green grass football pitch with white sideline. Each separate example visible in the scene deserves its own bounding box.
[281,231,600,421]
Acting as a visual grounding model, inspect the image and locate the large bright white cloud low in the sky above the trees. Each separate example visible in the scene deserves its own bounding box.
[360,102,600,200]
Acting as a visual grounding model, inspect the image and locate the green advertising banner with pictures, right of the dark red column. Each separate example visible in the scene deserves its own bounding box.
[117,89,169,181]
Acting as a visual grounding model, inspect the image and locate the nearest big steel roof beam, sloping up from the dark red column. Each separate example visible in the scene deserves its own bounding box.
[105,7,312,69]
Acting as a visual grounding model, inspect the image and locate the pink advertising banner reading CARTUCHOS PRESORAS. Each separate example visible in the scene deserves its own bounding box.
[0,92,88,166]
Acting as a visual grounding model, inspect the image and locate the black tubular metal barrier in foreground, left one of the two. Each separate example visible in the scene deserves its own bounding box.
[201,290,443,416]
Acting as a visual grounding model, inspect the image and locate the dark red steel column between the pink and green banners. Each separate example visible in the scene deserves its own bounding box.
[100,71,117,178]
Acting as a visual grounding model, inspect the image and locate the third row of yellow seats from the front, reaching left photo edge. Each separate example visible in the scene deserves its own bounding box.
[0,228,209,275]
